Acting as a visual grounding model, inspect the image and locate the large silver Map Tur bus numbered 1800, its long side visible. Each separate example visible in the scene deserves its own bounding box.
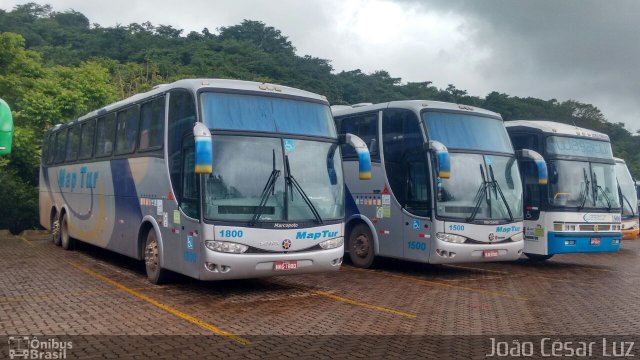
[40,79,370,283]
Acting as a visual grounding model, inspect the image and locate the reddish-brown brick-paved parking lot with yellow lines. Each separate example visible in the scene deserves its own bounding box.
[0,232,640,358]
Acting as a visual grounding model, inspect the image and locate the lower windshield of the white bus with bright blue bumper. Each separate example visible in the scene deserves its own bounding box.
[548,160,620,209]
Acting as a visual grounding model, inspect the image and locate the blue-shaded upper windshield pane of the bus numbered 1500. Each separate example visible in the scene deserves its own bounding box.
[422,111,513,153]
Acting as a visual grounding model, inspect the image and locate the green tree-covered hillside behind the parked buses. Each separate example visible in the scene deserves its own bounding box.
[0,3,640,232]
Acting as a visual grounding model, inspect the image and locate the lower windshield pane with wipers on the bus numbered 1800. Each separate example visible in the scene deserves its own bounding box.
[204,135,344,222]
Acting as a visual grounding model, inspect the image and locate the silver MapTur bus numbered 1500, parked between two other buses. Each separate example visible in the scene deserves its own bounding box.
[332,100,546,267]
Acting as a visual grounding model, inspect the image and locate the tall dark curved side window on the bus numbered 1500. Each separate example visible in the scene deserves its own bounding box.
[382,110,431,216]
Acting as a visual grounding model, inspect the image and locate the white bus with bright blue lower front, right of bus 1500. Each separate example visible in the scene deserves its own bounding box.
[506,120,622,260]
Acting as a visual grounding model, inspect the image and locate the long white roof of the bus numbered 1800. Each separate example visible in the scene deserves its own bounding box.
[51,79,329,130]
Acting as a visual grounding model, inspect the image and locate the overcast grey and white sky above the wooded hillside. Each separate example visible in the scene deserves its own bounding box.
[0,0,640,132]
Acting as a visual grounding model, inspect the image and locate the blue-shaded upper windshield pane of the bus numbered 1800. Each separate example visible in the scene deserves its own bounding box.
[200,92,336,138]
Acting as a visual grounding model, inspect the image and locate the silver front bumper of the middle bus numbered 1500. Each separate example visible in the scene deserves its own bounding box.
[429,239,524,264]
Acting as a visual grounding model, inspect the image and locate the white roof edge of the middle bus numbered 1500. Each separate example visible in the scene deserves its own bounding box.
[331,100,502,119]
